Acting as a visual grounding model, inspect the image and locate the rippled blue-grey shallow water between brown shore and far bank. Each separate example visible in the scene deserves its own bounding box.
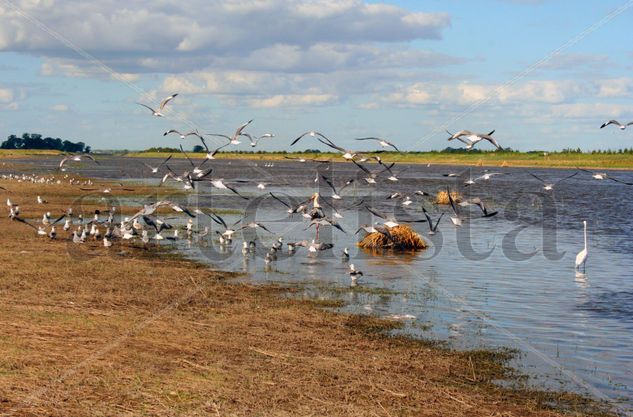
[4,158,633,411]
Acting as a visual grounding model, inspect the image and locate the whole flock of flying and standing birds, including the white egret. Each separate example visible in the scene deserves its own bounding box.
[0,94,633,285]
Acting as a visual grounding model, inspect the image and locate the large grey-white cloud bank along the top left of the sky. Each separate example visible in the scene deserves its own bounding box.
[0,0,450,74]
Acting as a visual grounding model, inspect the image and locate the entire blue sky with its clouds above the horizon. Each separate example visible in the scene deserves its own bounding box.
[0,0,633,151]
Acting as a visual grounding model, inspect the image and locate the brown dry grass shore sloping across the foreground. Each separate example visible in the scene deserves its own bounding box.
[0,177,612,416]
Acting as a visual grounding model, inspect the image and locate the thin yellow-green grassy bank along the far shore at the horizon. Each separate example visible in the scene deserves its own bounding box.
[126,152,633,169]
